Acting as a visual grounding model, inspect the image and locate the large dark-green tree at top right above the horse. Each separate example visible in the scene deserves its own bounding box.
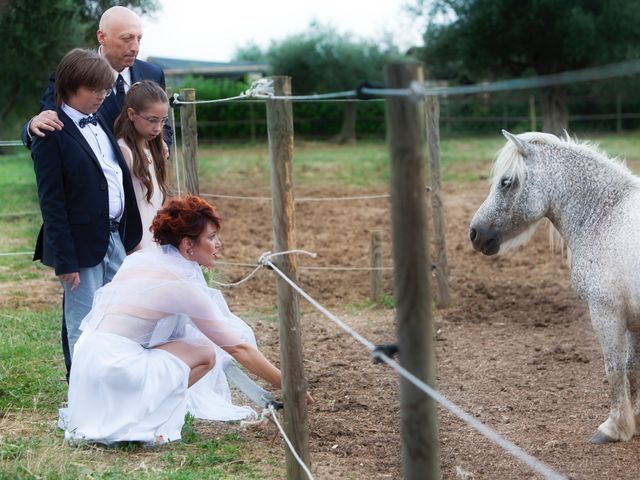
[416,0,640,134]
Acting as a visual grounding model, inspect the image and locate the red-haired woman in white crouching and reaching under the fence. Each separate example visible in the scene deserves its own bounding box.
[65,196,313,444]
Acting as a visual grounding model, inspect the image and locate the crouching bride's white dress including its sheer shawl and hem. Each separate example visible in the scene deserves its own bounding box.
[60,246,255,444]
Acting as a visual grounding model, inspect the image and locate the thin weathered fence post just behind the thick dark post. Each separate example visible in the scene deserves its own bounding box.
[425,96,451,308]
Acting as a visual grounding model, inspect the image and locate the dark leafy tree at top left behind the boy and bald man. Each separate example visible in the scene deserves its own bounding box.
[0,0,156,138]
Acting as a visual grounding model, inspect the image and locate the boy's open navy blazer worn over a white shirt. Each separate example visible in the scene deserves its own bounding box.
[31,108,142,275]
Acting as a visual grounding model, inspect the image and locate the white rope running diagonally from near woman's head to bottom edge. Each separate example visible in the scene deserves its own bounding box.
[259,251,566,480]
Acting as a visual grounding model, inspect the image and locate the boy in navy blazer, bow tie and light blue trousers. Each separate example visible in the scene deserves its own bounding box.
[31,49,142,375]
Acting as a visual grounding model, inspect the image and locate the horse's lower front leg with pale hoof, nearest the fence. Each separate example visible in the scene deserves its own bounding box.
[589,305,636,443]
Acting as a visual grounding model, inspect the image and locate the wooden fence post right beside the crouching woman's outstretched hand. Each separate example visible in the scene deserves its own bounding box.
[267,76,310,480]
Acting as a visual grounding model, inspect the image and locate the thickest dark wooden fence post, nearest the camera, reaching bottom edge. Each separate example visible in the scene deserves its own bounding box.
[385,63,440,480]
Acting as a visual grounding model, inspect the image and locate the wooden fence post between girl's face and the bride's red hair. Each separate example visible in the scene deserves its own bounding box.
[180,88,200,195]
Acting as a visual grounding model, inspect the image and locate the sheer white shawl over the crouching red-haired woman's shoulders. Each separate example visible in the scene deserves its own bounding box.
[81,245,250,347]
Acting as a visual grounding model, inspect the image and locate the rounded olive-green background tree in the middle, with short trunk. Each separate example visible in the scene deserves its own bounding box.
[266,23,400,143]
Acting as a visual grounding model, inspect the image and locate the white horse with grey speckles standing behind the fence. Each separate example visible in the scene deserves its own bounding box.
[470,130,640,443]
